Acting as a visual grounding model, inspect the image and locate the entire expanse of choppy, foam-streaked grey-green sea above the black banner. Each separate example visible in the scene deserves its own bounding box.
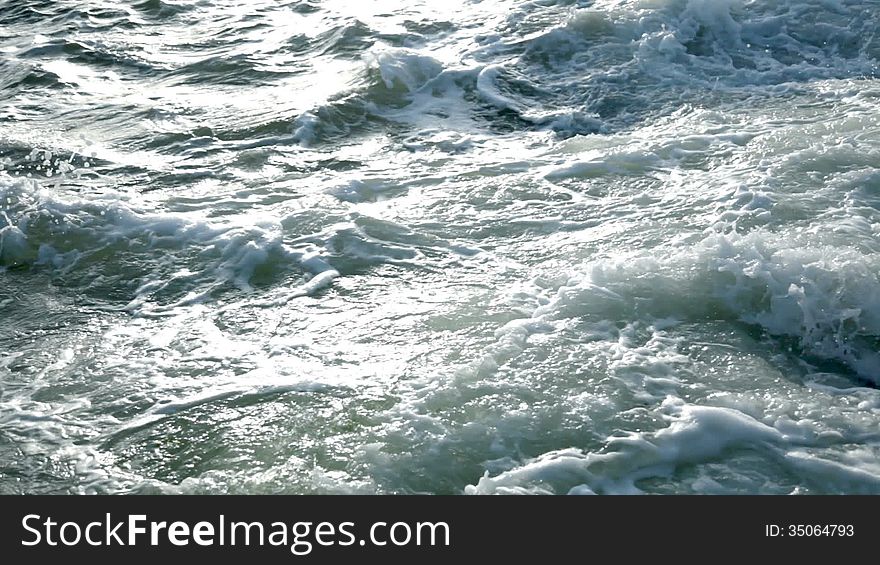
[0,0,880,494]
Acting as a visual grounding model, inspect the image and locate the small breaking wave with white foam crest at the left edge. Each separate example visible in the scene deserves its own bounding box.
[0,179,333,312]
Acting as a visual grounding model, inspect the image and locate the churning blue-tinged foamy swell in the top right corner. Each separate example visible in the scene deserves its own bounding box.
[468,0,880,133]
